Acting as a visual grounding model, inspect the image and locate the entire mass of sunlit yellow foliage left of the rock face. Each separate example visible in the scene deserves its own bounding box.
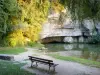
[7,0,50,47]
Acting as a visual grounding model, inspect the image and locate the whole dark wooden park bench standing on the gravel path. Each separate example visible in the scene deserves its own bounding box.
[28,56,58,71]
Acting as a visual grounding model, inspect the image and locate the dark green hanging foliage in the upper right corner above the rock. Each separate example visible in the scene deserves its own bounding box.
[60,0,100,20]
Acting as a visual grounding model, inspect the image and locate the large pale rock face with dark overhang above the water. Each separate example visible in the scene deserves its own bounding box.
[41,14,100,43]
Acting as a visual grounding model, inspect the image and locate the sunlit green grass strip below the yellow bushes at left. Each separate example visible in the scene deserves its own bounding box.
[0,47,26,54]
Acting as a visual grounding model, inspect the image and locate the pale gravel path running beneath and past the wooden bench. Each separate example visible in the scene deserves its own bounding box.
[16,48,100,75]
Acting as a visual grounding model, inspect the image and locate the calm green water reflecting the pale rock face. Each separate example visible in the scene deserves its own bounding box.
[45,43,100,62]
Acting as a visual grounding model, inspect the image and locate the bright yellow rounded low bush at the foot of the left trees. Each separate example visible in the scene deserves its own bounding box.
[7,29,26,47]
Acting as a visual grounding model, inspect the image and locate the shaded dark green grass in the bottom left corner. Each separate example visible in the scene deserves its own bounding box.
[0,60,36,75]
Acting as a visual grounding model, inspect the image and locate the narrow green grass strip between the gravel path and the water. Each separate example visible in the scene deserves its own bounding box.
[49,54,100,68]
